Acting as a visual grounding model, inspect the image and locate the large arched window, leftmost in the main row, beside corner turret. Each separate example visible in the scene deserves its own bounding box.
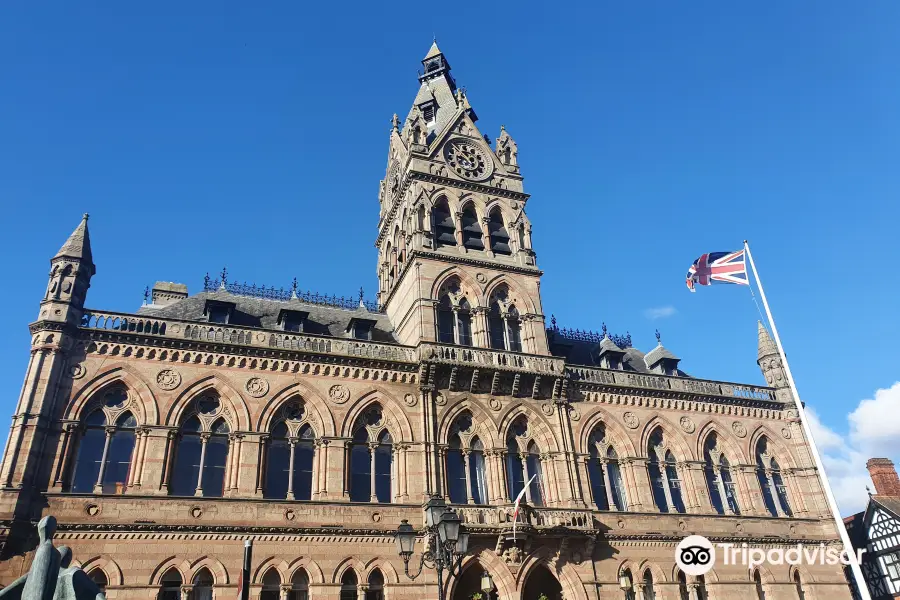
[71,398,137,494]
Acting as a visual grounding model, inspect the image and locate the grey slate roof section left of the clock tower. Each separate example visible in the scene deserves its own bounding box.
[138,292,397,343]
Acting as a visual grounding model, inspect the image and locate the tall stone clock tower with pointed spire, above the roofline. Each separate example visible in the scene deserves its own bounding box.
[375,42,549,355]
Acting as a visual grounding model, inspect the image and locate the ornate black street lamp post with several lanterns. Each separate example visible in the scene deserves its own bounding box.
[397,497,469,600]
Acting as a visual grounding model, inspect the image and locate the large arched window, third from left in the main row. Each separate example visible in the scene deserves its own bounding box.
[264,401,316,500]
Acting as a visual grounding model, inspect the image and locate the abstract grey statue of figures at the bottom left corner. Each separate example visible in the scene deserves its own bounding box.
[0,515,106,600]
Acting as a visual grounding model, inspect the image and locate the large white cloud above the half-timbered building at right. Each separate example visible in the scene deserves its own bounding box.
[806,381,900,516]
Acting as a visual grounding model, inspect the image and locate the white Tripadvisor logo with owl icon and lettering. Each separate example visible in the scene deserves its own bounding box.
[675,535,866,577]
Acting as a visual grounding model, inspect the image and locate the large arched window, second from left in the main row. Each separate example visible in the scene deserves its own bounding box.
[171,395,230,498]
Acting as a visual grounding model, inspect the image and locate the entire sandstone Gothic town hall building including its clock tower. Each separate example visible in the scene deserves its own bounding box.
[0,44,849,600]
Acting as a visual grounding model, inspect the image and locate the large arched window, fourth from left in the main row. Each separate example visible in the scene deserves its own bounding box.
[349,405,394,503]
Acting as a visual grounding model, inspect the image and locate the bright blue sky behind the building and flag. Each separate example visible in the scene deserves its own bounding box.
[0,1,900,511]
